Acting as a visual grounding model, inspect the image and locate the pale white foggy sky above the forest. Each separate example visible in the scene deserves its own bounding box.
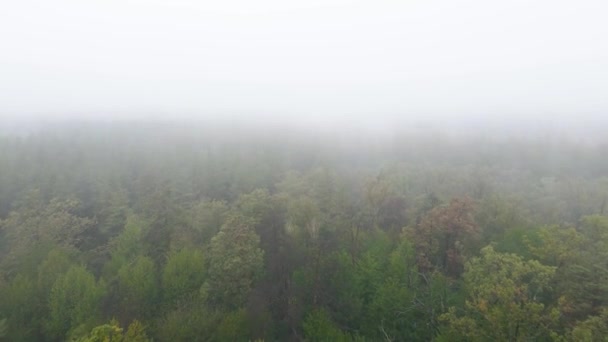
[0,0,608,119]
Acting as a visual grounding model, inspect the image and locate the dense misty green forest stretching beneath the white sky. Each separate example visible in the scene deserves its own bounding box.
[0,123,608,341]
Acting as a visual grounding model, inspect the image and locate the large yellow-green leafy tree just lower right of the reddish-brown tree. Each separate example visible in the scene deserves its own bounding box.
[441,246,559,341]
